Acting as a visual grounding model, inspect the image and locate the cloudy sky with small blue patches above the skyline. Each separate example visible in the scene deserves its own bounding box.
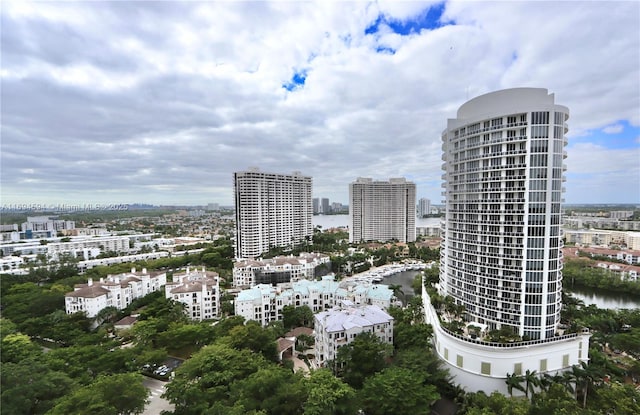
[0,0,640,207]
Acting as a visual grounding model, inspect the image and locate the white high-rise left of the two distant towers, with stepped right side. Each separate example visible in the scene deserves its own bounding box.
[233,169,313,258]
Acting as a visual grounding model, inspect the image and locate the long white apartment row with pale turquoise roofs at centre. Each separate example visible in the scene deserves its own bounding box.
[235,275,395,326]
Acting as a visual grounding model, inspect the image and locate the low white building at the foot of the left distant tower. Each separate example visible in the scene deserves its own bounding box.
[233,252,331,287]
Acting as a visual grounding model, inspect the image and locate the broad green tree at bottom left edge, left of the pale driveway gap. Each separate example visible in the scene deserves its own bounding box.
[49,373,149,415]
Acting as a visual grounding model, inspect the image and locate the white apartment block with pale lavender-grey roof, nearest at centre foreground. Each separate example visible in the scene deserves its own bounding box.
[314,301,393,367]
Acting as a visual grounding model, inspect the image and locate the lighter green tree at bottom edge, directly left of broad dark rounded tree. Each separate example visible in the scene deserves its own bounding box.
[304,369,358,415]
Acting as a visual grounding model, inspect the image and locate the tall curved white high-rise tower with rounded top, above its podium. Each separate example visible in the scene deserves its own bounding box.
[440,88,569,339]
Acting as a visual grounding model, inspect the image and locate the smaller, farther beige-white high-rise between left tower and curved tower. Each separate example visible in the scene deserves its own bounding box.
[349,177,416,243]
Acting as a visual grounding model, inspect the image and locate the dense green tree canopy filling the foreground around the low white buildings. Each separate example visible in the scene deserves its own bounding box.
[0,228,640,415]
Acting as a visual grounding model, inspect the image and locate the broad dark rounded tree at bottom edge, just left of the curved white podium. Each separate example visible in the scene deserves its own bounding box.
[360,367,440,415]
